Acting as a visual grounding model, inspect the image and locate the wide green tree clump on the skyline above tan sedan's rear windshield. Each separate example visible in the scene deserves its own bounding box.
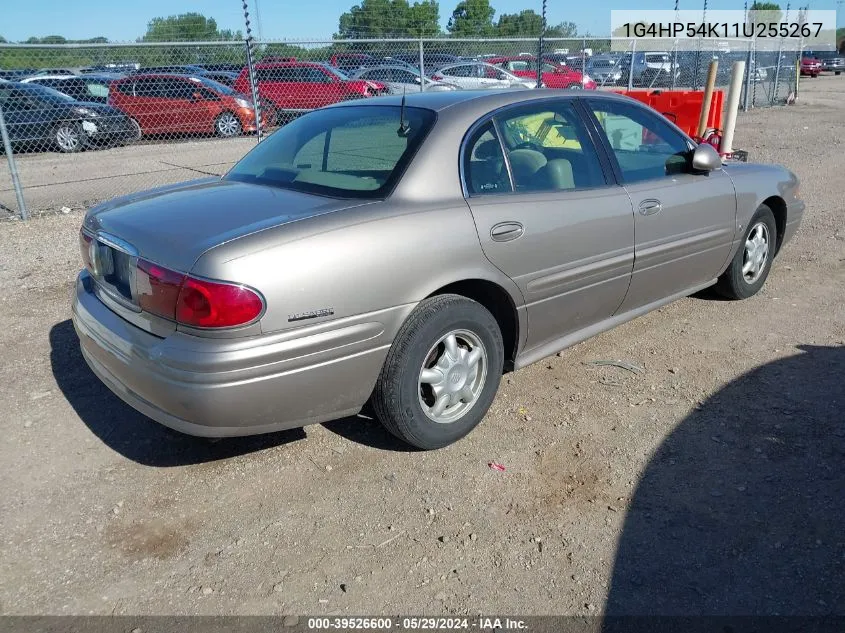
[335,0,440,39]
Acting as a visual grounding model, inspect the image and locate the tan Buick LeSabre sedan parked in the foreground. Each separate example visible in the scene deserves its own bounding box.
[73,90,804,449]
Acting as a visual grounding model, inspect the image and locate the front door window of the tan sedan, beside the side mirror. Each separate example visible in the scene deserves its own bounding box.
[589,99,691,183]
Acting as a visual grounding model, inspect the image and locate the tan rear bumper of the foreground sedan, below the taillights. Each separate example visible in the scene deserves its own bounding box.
[73,271,404,437]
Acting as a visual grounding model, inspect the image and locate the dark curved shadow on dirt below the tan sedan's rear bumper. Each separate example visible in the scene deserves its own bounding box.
[50,320,306,467]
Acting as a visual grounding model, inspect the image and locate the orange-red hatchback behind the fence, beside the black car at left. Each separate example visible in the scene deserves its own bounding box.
[109,74,269,138]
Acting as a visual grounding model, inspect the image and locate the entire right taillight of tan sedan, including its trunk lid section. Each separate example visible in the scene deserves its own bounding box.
[135,259,264,328]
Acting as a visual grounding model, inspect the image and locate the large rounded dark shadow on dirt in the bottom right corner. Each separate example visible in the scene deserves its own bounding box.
[604,346,845,616]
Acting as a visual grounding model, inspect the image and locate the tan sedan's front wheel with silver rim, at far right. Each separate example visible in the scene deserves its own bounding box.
[716,204,777,299]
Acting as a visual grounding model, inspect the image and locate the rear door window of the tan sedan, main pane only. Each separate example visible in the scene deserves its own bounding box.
[498,101,607,192]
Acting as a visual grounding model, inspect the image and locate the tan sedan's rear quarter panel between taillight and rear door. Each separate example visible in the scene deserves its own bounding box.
[188,199,523,337]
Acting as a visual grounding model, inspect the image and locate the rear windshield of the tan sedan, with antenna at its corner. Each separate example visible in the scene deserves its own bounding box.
[225,106,435,198]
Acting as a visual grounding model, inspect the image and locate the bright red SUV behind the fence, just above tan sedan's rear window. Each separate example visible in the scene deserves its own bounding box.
[235,62,388,112]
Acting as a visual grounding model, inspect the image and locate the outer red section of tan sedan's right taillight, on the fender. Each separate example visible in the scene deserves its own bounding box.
[176,277,264,327]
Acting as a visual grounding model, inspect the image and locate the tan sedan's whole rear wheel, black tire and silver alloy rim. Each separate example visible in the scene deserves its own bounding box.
[372,295,504,450]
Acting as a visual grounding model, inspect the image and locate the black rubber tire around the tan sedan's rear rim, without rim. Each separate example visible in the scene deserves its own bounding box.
[371,294,504,450]
